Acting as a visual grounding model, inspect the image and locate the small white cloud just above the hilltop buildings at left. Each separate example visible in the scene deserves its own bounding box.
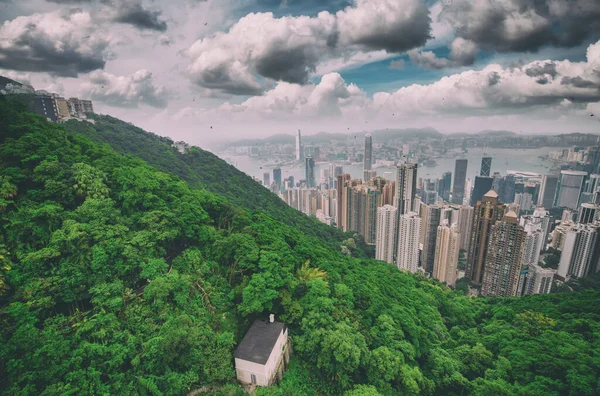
[81,69,168,108]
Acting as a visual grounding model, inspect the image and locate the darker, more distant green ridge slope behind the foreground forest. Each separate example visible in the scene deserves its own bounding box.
[64,115,372,255]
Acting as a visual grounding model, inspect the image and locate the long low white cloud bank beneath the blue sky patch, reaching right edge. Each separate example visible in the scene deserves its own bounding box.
[186,41,600,120]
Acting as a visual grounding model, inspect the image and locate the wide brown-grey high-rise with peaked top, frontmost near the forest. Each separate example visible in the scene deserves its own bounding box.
[481,211,525,296]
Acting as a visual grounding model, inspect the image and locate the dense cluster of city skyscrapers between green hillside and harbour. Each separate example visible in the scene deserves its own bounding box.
[264,131,600,296]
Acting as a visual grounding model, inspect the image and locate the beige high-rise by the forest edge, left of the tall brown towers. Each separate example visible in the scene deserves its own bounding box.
[432,220,460,286]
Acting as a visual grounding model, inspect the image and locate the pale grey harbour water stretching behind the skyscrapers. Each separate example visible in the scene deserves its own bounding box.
[221,147,560,186]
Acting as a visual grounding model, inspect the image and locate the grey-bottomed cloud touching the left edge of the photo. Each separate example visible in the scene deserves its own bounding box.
[0,11,110,77]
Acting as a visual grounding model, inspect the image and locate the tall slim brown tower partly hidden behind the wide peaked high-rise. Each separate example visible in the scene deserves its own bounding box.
[465,190,504,285]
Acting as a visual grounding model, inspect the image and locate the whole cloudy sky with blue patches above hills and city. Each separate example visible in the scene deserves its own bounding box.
[0,0,600,146]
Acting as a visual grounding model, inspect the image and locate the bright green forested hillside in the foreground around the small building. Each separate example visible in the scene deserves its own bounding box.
[0,98,600,396]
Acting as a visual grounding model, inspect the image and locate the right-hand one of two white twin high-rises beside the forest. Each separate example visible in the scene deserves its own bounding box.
[396,212,421,272]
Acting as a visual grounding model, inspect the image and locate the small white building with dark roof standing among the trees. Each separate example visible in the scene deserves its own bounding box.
[233,316,290,386]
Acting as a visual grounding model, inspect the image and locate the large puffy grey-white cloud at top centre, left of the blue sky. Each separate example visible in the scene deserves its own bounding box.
[186,0,430,95]
